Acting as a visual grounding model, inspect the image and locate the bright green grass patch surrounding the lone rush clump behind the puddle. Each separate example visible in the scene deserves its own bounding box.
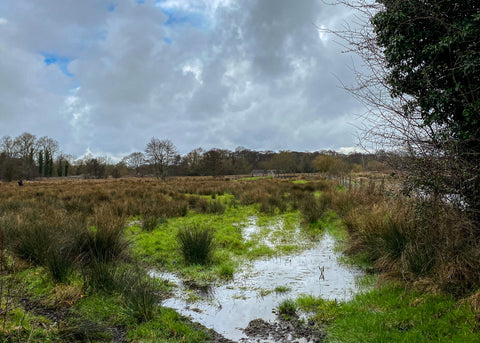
[127,203,308,282]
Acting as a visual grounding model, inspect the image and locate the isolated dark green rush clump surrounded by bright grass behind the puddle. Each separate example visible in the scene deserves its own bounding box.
[177,225,215,264]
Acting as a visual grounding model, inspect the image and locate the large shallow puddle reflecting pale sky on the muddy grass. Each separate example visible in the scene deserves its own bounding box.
[151,222,361,342]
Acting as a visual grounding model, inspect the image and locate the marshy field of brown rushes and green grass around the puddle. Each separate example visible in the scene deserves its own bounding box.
[0,177,479,342]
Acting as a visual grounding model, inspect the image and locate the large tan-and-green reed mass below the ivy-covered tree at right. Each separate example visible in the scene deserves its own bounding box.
[333,190,480,296]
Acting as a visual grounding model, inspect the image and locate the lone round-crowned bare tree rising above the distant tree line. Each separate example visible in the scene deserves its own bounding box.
[145,137,177,178]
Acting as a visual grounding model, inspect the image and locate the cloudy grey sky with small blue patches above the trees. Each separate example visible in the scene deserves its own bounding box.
[0,0,361,156]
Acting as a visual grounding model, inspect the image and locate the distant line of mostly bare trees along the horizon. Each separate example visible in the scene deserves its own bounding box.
[0,132,388,181]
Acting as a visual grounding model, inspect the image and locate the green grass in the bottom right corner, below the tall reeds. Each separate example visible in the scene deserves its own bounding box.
[296,285,478,342]
